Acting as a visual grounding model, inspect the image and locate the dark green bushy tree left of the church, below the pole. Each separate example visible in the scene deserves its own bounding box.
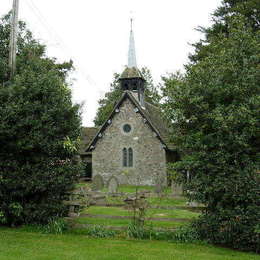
[0,16,81,225]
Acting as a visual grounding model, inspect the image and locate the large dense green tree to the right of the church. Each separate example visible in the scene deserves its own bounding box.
[164,13,260,251]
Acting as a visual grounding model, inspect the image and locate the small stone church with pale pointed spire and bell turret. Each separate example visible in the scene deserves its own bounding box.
[81,23,177,185]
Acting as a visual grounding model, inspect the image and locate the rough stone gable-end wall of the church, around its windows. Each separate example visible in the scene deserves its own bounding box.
[92,99,166,185]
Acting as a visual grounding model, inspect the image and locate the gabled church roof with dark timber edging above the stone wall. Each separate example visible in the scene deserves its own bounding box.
[86,91,174,152]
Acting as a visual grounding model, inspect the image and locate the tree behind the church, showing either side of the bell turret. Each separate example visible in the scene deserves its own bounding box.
[94,67,160,127]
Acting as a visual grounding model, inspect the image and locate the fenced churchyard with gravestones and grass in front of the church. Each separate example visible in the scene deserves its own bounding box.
[65,179,203,232]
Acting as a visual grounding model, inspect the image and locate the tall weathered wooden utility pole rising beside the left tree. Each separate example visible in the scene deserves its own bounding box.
[9,0,19,79]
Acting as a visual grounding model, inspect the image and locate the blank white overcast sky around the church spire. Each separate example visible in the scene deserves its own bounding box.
[0,0,221,126]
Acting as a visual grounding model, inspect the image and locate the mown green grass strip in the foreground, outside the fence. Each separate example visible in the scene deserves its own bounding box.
[0,228,259,260]
